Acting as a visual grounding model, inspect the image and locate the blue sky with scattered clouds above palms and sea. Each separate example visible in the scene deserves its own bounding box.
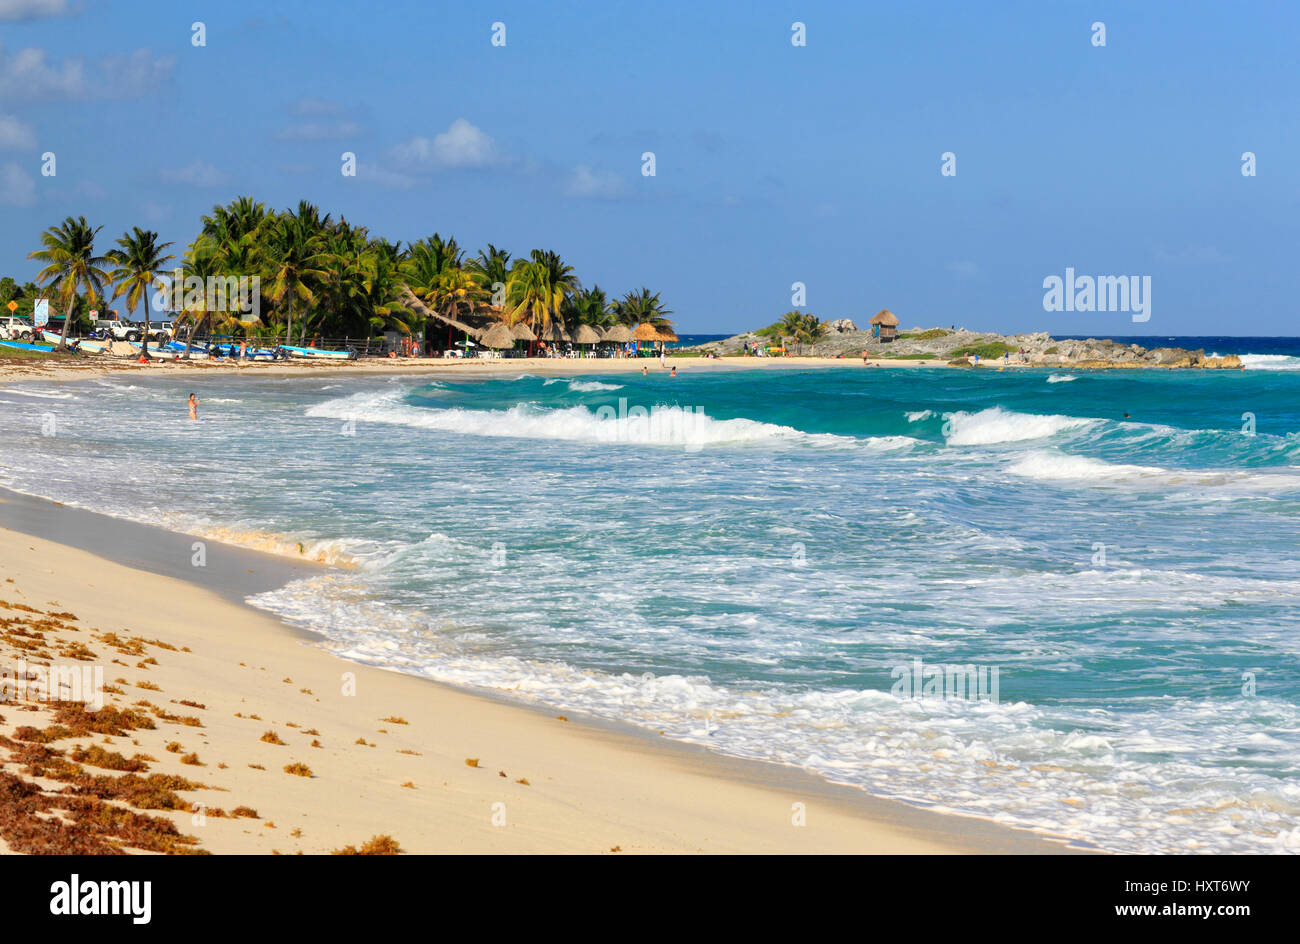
[0,0,1300,335]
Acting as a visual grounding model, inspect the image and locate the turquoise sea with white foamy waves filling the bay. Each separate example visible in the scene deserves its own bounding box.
[0,366,1300,852]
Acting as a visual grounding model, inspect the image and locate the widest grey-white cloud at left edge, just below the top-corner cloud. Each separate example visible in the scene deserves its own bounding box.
[0,47,176,101]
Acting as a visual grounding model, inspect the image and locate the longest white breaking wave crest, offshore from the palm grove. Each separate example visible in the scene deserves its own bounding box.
[307,391,873,447]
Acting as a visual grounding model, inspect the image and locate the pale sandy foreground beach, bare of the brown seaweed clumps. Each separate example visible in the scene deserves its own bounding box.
[0,490,1092,853]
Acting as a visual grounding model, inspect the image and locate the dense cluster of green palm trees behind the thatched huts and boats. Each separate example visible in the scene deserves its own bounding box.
[20,196,672,356]
